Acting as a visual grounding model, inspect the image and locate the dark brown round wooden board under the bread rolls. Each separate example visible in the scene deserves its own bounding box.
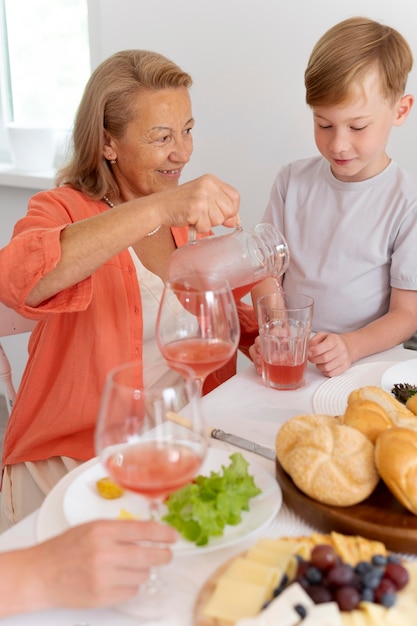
[275,459,417,554]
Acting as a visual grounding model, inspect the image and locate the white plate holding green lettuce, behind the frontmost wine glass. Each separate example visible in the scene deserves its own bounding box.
[37,448,282,556]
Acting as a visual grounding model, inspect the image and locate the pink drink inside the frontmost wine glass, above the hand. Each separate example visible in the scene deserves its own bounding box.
[104,441,202,498]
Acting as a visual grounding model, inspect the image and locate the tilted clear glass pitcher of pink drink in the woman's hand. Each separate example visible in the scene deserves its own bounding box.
[168,224,290,300]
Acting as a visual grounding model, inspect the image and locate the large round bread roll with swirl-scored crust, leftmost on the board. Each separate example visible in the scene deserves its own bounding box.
[275,415,379,506]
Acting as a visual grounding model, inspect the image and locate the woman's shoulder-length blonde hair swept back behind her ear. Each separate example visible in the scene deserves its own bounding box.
[56,50,192,199]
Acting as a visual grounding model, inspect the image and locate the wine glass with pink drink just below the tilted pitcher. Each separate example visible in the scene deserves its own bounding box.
[156,274,240,394]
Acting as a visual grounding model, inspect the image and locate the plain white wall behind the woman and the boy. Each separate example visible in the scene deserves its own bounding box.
[90,0,417,227]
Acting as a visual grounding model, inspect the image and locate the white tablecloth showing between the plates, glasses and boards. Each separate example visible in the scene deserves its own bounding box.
[0,348,417,626]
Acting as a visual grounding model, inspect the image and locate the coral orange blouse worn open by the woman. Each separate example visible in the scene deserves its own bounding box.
[0,187,257,466]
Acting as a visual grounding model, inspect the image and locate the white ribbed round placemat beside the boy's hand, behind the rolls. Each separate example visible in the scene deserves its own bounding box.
[313,361,396,415]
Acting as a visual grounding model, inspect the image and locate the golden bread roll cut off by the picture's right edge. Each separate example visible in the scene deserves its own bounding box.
[375,427,417,515]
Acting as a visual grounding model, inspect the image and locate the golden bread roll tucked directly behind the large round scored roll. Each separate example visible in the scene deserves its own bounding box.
[343,400,394,443]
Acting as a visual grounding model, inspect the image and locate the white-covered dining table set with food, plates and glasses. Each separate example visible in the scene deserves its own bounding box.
[0,346,417,626]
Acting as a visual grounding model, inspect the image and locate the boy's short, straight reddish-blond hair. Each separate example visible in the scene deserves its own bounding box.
[304,17,413,107]
